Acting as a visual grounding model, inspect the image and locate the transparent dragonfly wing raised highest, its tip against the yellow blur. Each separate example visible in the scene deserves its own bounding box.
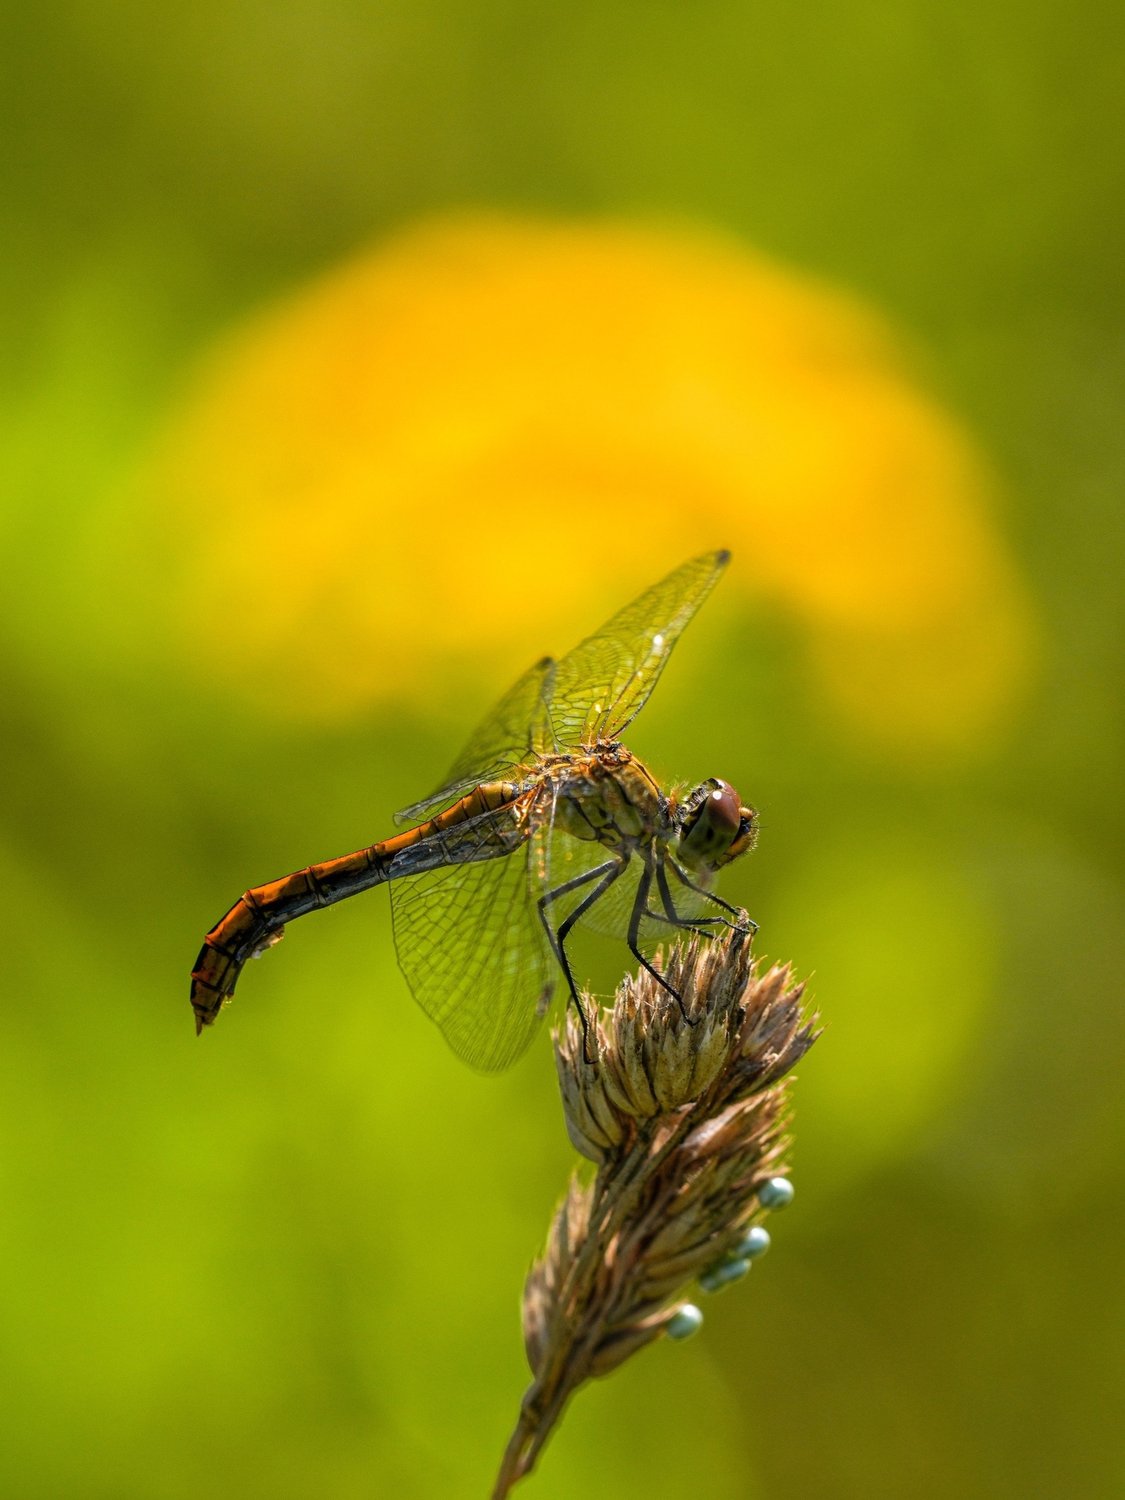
[546,552,731,750]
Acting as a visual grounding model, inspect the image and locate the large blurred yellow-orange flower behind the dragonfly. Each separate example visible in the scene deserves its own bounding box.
[123,218,1029,749]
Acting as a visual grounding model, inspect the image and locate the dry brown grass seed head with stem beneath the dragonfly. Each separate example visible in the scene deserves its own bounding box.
[494,932,816,1500]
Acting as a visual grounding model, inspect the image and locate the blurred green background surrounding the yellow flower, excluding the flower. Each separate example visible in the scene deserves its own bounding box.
[0,0,1125,1500]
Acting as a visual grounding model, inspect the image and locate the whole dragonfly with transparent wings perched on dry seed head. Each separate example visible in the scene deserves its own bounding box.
[191,551,758,1071]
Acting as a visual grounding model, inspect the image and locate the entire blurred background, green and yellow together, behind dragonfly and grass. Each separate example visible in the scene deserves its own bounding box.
[0,0,1125,1500]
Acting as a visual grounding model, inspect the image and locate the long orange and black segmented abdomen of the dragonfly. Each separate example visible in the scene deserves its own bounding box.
[192,782,527,1035]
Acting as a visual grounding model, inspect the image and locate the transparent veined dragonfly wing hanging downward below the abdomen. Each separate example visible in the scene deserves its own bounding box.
[390,809,555,1073]
